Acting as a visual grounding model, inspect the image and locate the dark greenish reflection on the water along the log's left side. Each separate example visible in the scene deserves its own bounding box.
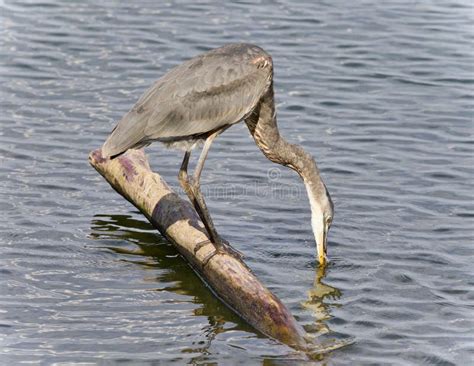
[90,215,264,355]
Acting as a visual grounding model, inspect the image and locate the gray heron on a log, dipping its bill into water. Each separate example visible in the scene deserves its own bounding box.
[102,44,334,264]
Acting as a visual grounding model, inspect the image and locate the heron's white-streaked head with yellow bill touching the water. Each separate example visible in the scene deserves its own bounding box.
[305,176,334,265]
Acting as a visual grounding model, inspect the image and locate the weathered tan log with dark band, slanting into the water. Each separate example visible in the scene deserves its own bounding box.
[89,149,306,349]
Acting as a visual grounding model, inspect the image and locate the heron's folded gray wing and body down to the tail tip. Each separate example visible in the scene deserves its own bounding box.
[103,44,272,156]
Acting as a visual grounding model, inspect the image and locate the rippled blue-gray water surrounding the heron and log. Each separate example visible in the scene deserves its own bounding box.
[0,0,474,365]
